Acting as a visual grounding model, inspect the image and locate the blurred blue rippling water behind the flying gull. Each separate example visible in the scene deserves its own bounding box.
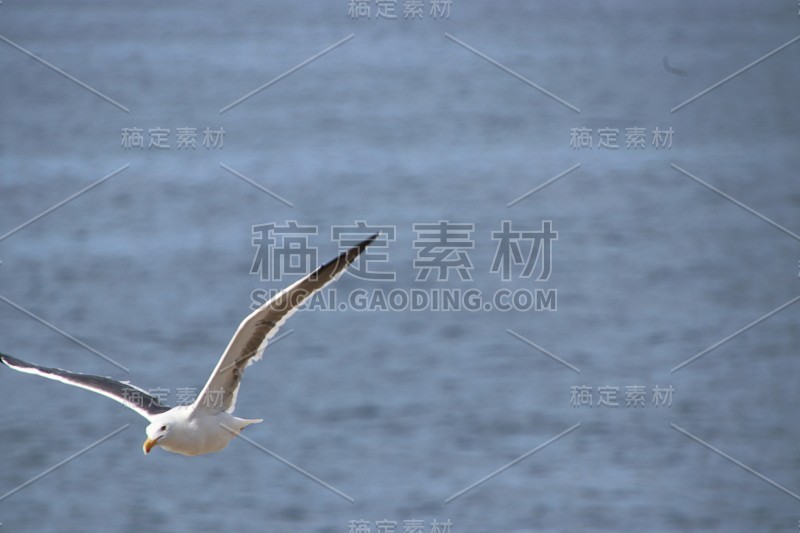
[0,0,800,533]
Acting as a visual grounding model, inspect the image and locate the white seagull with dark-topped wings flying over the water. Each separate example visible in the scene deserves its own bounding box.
[0,233,379,455]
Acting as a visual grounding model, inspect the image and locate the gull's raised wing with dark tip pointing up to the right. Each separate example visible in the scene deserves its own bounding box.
[193,233,379,413]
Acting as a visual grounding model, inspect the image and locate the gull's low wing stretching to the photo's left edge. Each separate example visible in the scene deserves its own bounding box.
[0,354,170,420]
